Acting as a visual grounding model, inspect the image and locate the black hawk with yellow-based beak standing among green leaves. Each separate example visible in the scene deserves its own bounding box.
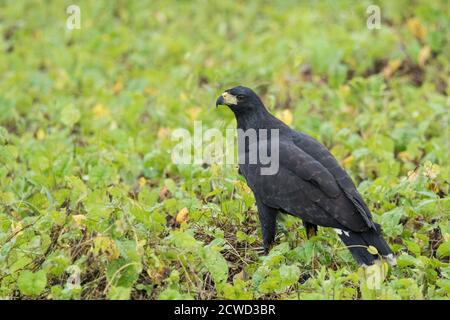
[216,86,393,265]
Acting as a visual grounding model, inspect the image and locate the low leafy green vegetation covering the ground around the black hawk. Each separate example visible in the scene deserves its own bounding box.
[0,0,450,299]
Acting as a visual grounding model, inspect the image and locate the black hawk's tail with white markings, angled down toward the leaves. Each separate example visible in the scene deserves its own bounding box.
[336,224,396,266]
